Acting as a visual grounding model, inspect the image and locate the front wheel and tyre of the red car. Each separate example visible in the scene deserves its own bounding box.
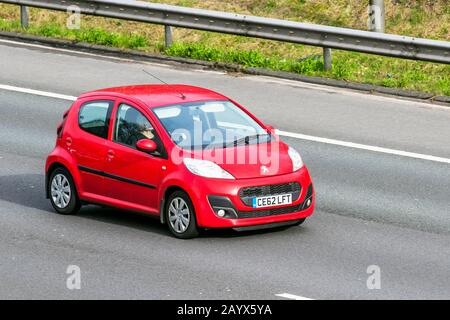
[164,190,199,239]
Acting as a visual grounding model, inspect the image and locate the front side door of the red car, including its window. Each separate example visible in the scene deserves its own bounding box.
[105,100,167,214]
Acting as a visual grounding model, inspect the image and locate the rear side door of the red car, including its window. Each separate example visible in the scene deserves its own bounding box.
[70,97,114,196]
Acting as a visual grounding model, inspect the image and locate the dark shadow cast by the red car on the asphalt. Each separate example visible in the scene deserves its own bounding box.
[0,174,304,238]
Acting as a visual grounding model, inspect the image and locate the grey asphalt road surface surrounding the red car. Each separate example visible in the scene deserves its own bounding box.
[0,40,450,299]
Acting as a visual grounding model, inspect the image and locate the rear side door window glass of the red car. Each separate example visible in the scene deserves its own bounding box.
[78,101,113,139]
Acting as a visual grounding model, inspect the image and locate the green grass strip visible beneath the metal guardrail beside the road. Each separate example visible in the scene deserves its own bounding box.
[0,0,450,96]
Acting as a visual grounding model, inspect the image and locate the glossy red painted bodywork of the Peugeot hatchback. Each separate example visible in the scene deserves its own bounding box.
[45,85,315,228]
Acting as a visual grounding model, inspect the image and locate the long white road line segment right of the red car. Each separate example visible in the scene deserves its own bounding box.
[276,130,450,164]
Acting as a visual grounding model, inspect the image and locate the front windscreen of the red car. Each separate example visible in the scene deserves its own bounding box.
[153,101,271,149]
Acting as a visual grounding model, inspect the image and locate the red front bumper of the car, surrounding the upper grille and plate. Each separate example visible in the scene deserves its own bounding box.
[190,167,315,228]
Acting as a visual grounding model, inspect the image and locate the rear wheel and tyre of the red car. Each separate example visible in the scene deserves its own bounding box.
[48,167,81,215]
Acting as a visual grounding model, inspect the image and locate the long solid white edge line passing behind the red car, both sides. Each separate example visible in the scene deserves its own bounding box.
[0,84,450,164]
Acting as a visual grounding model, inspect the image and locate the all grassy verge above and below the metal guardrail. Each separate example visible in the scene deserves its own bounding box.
[0,0,450,95]
